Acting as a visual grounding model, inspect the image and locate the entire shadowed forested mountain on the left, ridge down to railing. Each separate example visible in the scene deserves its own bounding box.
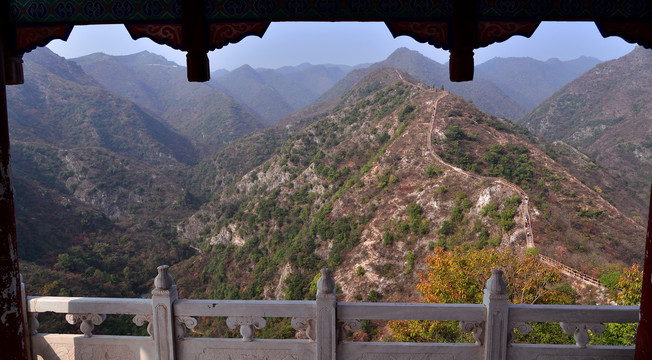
[8,49,199,296]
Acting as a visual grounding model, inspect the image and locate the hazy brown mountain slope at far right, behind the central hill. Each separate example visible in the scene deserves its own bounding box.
[519,47,652,218]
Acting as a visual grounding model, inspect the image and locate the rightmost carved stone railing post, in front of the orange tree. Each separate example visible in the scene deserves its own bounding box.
[483,269,511,360]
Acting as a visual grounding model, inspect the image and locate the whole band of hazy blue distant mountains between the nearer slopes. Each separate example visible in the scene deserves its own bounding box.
[67,48,598,129]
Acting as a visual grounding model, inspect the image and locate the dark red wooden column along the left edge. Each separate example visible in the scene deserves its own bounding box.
[0,26,27,359]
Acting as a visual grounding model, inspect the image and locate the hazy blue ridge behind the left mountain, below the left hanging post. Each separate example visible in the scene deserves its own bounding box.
[73,51,265,154]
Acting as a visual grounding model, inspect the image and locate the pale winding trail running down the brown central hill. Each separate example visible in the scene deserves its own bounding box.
[426,92,604,289]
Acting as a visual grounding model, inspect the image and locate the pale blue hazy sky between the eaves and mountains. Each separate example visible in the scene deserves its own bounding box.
[48,22,634,71]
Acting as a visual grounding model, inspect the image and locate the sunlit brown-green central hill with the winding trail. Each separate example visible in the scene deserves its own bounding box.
[175,69,644,301]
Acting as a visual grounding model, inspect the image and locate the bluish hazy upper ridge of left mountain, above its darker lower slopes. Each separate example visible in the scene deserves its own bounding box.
[8,48,197,164]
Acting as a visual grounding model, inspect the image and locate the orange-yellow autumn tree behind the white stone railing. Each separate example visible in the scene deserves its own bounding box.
[389,247,575,343]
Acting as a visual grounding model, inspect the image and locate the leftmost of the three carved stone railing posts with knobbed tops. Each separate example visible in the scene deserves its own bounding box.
[152,265,178,360]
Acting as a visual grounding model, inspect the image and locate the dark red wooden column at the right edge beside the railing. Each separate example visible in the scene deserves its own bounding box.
[635,186,652,360]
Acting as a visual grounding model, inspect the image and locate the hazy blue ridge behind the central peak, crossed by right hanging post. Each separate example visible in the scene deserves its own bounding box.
[320,48,597,120]
